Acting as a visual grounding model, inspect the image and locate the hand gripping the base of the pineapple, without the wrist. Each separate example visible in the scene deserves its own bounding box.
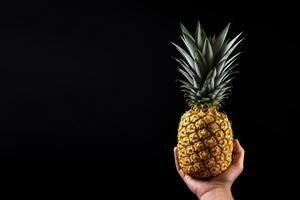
[174,139,245,199]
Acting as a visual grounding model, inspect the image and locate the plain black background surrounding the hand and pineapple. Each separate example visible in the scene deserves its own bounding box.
[0,1,299,199]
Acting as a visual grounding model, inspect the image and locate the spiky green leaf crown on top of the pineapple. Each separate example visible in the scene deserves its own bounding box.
[172,21,243,107]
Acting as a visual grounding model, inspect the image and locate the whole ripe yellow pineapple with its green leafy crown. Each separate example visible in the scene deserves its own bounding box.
[172,22,242,178]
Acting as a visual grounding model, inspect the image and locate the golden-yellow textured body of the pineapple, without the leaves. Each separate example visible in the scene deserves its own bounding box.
[177,107,233,179]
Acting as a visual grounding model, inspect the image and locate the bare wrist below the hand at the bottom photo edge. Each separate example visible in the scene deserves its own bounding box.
[197,186,233,200]
